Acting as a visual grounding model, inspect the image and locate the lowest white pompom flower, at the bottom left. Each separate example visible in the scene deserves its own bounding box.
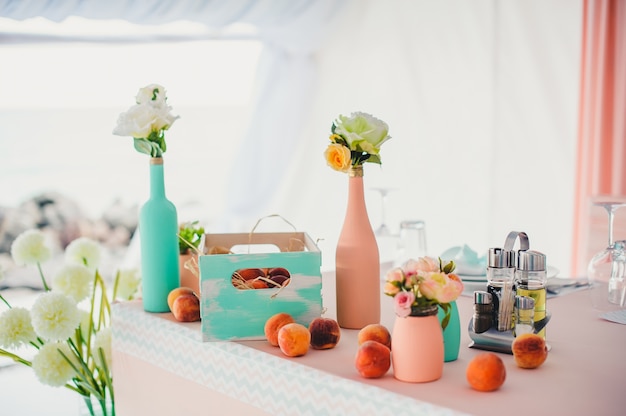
[33,342,75,387]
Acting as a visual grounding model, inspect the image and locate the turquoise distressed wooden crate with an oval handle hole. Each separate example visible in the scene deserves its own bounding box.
[198,232,322,341]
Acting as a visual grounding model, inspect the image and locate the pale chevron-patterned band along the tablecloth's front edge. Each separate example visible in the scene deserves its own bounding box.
[112,301,461,416]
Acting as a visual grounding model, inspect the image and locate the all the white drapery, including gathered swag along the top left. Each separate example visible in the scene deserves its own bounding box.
[0,0,582,275]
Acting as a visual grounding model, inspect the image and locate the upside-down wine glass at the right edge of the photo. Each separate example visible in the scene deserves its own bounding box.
[587,201,626,312]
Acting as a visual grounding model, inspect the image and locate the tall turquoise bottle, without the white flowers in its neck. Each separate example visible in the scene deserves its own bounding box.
[139,157,180,312]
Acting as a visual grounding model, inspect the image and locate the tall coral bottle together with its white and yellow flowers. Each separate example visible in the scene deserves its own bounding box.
[324,112,390,329]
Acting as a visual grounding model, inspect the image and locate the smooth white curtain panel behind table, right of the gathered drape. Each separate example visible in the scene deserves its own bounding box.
[256,0,581,275]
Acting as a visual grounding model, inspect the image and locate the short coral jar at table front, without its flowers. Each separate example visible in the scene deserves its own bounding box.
[391,305,444,383]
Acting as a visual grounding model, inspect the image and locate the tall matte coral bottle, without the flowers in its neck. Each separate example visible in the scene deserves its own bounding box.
[335,166,381,329]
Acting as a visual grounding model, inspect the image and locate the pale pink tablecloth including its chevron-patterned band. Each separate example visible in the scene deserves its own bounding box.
[112,274,626,416]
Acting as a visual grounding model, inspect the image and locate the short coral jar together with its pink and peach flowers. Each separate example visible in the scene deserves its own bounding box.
[384,257,463,383]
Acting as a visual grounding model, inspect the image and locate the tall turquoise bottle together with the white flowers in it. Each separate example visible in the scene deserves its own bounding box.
[113,84,180,312]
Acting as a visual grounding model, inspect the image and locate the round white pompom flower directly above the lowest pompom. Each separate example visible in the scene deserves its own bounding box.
[30,291,81,341]
